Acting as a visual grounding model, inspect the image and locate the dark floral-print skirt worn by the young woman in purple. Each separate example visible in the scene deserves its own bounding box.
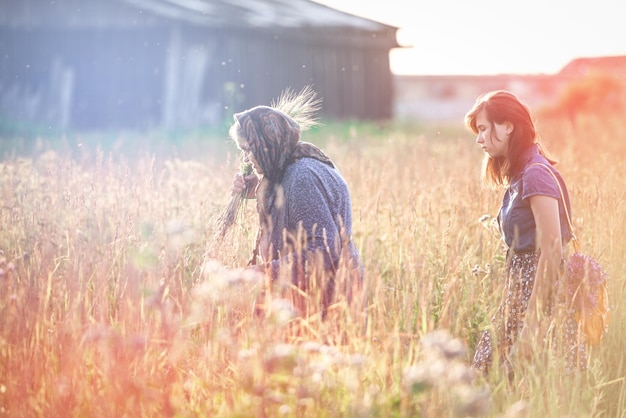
[472,252,587,374]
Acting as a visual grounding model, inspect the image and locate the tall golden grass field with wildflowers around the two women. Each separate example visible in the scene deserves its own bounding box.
[0,112,626,417]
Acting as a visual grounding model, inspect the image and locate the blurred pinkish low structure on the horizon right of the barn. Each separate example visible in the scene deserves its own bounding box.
[394,56,626,124]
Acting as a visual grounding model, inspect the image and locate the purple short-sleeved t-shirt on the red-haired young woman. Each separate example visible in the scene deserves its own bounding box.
[498,145,571,252]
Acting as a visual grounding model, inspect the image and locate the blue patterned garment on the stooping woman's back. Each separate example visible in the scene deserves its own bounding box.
[260,158,361,277]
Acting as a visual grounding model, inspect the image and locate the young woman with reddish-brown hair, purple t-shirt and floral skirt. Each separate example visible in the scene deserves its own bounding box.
[465,90,587,372]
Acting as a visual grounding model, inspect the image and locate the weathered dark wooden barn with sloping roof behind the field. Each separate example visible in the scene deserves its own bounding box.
[0,0,399,132]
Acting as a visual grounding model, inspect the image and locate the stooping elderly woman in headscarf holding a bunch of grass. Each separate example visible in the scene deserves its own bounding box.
[225,89,362,318]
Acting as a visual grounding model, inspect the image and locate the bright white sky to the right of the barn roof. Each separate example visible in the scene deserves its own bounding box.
[316,0,626,75]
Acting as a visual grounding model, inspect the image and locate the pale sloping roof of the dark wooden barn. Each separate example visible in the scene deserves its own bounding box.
[0,0,397,32]
